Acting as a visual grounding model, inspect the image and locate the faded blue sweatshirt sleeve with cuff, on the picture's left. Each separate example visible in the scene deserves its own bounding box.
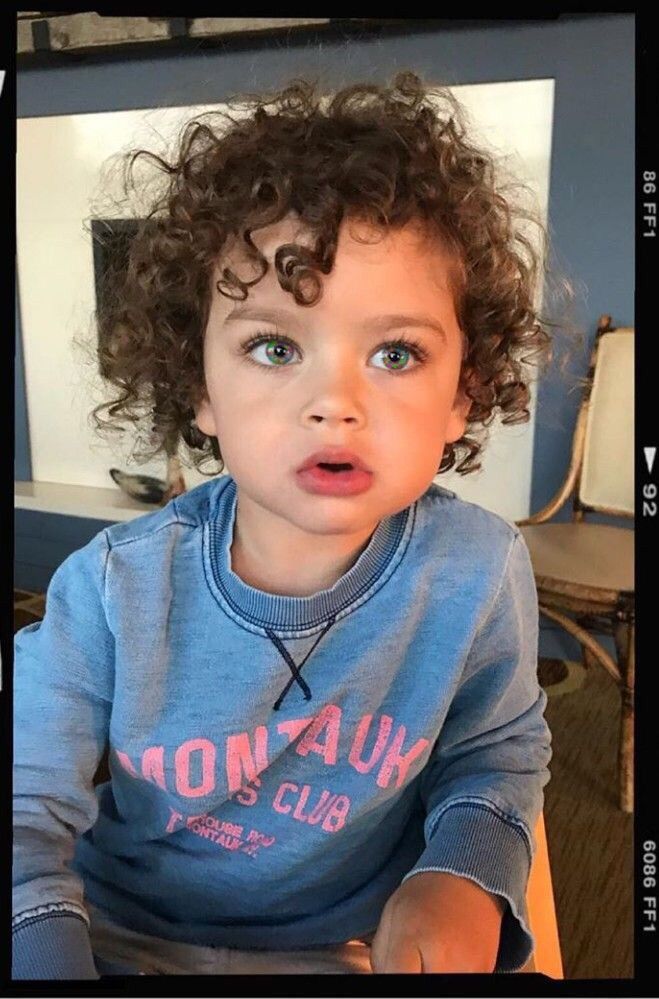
[12,532,114,979]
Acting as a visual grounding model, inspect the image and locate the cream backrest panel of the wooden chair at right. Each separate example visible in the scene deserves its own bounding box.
[577,327,634,516]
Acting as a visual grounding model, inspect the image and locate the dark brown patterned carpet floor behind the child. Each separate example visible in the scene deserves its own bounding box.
[14,590,634,979]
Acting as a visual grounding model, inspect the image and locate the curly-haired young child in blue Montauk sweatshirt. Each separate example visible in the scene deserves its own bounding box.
[13,73,551,979]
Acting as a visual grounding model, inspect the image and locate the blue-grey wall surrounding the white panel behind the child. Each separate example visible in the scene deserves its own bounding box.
[16,14,635,654]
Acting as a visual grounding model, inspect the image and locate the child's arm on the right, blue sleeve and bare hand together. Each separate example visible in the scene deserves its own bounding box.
[373,533,552,972]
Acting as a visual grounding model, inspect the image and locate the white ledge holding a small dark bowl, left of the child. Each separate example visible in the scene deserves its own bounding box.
[14,482,160,521]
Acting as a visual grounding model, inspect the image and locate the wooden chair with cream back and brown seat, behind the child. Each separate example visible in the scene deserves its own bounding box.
[517,316,635,812]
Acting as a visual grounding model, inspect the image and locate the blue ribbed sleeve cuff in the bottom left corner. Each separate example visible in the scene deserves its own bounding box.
[11,911,100,980]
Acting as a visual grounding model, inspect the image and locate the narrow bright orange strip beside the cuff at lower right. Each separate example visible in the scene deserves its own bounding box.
[526,812,564,978]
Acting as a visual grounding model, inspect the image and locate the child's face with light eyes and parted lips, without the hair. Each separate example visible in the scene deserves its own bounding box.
[196,218,469,548]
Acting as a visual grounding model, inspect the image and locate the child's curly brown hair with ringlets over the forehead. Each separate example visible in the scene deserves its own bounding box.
[92,71,576,474]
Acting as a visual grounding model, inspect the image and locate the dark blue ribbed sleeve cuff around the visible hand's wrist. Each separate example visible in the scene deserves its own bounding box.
[403,803,535,973]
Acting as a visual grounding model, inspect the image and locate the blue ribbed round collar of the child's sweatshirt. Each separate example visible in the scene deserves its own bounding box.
[204,475,416,638]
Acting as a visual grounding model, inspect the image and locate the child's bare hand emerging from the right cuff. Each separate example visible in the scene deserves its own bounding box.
[371,871,505,974]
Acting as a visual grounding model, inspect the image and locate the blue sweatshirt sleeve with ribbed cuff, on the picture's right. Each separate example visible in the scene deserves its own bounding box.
[404,533,552,972]
